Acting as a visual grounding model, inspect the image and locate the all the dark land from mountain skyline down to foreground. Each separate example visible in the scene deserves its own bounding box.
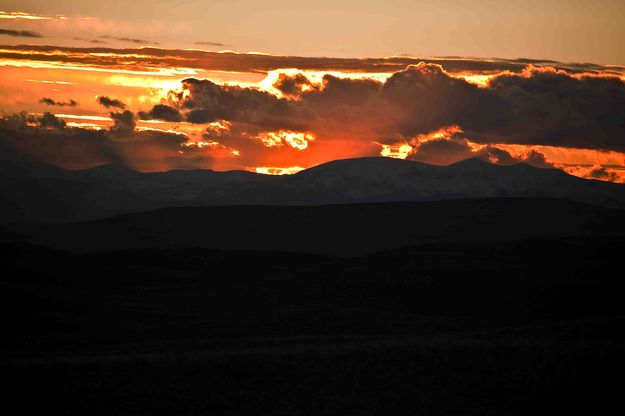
[0,158,625,416]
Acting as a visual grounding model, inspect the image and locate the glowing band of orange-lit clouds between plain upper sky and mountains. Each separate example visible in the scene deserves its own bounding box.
[0,52,625,181]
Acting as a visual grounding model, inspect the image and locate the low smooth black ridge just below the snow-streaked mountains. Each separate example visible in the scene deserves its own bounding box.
[5,198,625,256]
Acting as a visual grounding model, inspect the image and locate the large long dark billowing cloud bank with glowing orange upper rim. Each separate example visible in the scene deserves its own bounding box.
[174,63,625,152]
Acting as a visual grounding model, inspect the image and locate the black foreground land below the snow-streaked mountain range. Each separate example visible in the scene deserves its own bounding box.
[0,200,625,415]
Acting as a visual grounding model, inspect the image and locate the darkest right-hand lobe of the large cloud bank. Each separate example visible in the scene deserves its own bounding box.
[462,69,625,151]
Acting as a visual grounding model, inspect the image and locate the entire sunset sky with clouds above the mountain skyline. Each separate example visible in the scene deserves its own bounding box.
[0,0,625,182]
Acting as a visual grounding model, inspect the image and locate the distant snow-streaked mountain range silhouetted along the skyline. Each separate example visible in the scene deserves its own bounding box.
[0,157,625,222]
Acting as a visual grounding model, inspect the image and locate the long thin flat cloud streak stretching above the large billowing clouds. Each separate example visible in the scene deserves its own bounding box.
[0,45,625,75]
